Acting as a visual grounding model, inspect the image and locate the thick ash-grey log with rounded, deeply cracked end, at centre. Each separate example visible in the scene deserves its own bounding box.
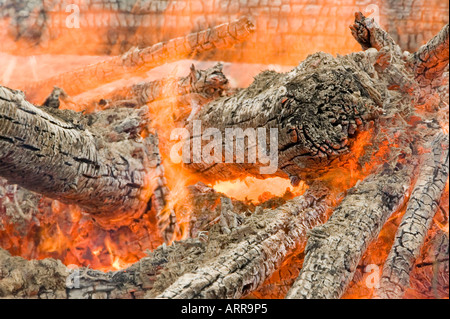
[185,53,389,185]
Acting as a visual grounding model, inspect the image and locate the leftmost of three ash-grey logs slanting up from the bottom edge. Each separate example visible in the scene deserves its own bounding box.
[157,188,328,299]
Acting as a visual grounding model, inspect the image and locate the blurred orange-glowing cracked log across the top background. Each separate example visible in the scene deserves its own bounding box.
[0,0,449,65]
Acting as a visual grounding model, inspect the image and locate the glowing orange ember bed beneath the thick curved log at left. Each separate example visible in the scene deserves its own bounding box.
[0,179,250,276]
